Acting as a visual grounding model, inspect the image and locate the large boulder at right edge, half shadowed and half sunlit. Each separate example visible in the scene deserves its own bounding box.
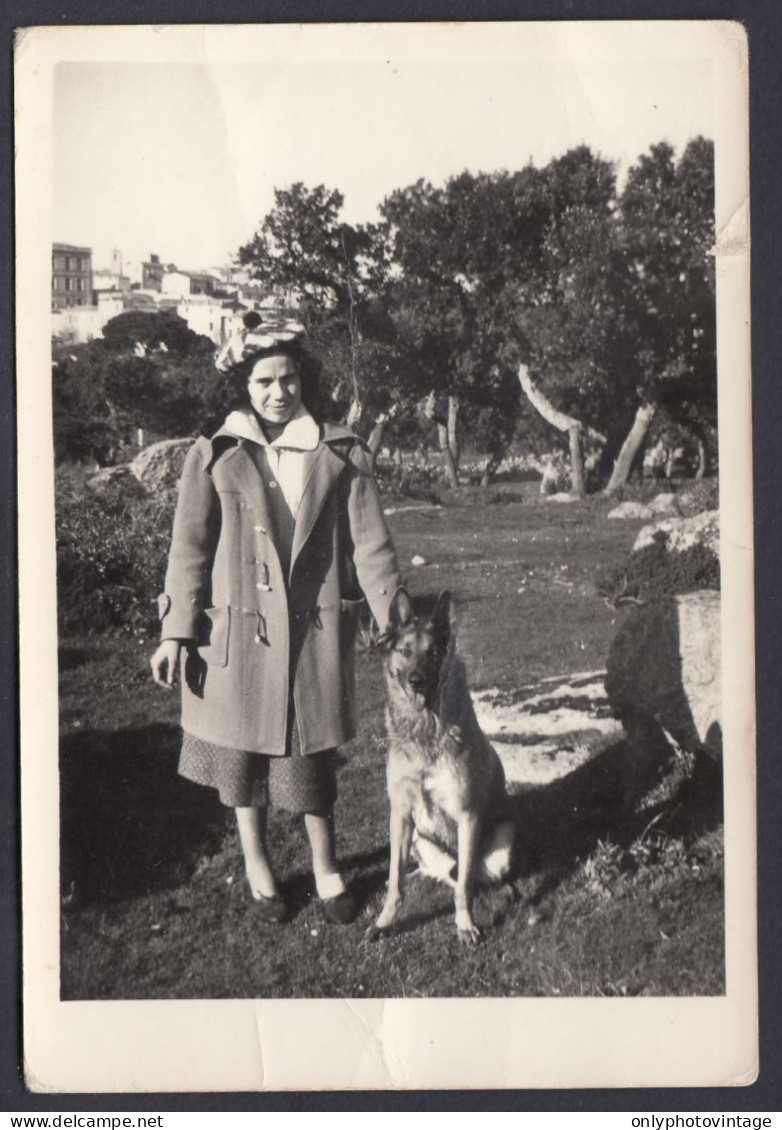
[606,591,722,756]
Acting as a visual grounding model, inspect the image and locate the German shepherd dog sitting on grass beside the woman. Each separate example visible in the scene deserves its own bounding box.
[367,589,515,944]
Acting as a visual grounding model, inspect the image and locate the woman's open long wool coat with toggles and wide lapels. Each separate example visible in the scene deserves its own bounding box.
[159,424,401,755]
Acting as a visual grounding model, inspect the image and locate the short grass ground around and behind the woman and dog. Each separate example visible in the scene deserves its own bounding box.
[60,499,724,1000]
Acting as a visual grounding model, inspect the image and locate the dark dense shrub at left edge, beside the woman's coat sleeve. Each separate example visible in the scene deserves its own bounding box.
[55,469,175,636]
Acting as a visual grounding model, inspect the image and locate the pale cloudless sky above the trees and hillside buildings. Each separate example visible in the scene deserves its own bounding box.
[52,41,713,269]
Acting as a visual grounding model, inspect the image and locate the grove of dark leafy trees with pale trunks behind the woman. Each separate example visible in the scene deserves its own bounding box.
[230,138,716,494]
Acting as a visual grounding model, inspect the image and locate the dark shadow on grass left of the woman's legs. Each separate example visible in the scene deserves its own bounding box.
[60,724,226,906]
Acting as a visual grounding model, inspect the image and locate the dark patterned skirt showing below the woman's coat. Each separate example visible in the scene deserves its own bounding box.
[179,725,338,816]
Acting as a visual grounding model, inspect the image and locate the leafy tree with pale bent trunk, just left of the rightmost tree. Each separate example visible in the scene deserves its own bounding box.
[463,146,615,494]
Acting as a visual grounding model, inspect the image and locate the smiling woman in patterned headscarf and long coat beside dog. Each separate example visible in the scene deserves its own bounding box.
[151,313,401,923]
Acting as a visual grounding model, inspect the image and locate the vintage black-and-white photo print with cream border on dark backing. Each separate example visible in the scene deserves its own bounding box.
[17,23,756,1089]
